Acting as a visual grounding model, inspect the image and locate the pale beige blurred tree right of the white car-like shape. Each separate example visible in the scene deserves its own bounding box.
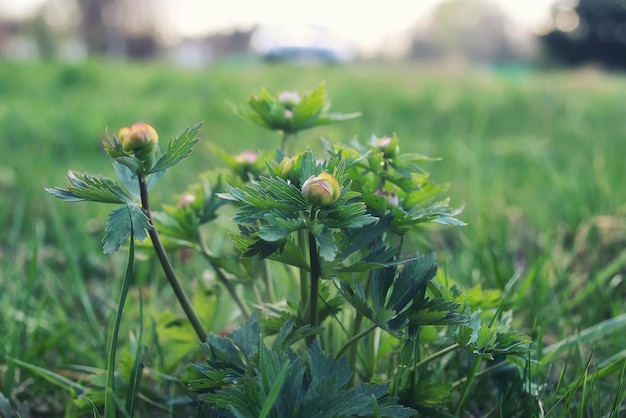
[409,0,514,63]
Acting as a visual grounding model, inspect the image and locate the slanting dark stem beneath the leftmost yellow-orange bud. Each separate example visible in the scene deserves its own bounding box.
[139,175,207,342]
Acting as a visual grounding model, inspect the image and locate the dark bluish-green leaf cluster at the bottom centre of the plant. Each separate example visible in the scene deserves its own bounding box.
[189,320,415,418]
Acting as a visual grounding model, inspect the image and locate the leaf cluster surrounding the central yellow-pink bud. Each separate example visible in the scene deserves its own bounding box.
[222,150,376,266]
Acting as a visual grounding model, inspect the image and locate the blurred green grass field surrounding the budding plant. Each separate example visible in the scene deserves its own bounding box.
[0,61,626,417]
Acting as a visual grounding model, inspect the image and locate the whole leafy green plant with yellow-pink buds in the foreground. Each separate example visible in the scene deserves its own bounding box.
[41,84,534,417]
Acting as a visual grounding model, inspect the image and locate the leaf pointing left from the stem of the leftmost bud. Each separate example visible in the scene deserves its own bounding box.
[45,171,132,204]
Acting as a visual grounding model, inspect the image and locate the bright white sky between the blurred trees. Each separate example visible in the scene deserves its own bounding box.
[0,0,553,54]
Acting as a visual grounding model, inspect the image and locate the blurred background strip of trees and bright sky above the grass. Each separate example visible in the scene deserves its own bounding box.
[0,0,626,68]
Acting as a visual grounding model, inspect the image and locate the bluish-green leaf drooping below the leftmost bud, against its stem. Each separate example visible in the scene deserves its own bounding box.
[102,202,152,254]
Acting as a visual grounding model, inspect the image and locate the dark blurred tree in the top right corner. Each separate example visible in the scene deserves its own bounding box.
[540,0,626,68]
